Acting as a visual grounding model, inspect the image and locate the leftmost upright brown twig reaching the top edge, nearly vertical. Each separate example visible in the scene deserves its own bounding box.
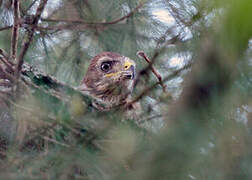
[10,0,20,61]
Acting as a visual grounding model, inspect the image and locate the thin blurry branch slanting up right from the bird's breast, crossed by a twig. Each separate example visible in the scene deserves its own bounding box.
[128,64,192,106]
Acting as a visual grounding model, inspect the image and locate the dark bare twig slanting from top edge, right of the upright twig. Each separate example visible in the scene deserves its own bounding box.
[15,0,47,80]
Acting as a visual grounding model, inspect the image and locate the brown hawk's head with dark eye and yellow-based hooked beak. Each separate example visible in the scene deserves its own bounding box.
[80,52,136,104]
